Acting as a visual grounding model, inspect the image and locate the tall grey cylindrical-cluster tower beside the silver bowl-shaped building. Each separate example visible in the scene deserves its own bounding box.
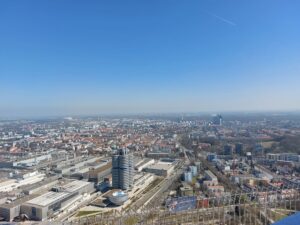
[112,149,134,190]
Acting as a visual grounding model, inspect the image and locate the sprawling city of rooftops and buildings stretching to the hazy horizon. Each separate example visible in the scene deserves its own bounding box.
[0,113,300,225]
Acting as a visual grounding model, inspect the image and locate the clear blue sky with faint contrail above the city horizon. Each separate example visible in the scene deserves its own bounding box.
[0,0,300,117]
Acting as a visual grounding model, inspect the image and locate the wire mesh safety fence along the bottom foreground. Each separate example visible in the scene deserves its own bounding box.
[64,184,300,225]
